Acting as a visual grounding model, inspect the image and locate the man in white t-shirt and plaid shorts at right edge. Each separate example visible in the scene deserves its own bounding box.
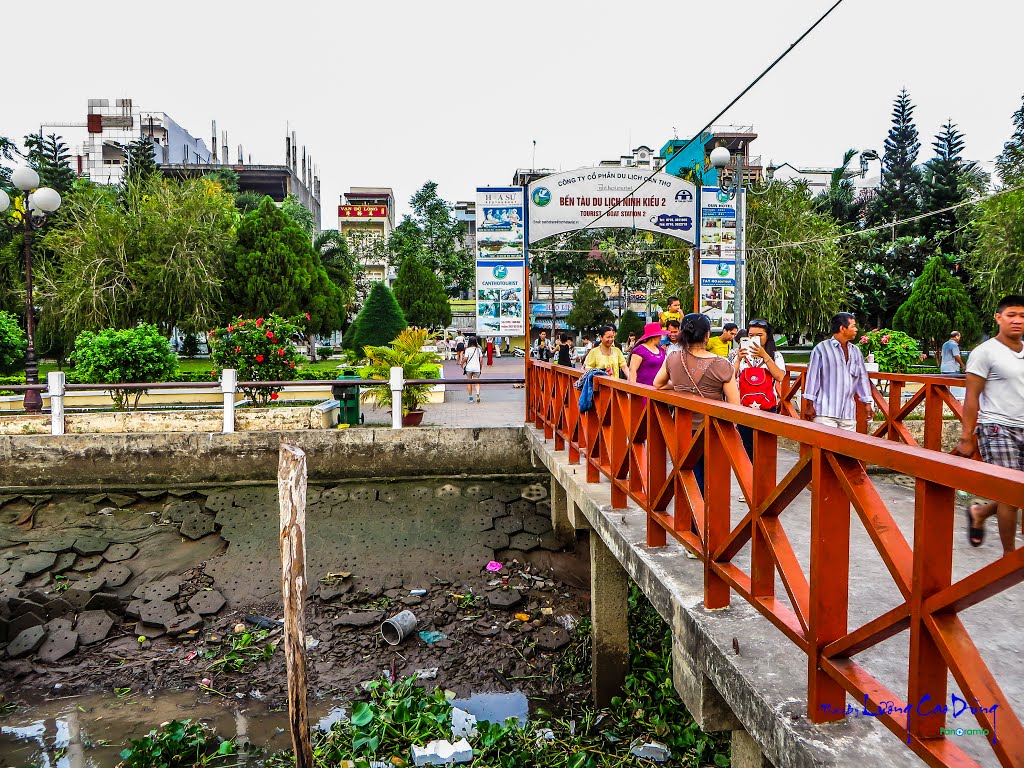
[953,296,1024,555]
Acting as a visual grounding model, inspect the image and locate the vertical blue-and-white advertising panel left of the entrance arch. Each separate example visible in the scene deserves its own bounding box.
[476,186,526,336]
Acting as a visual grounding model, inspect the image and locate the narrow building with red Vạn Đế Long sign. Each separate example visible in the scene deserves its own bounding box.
[338,186,395,288]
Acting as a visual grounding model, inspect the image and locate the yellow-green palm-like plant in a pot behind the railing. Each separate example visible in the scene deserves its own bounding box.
[359,329,437,427]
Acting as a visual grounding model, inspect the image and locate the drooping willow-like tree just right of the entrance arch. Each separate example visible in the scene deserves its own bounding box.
[746,180,846,336]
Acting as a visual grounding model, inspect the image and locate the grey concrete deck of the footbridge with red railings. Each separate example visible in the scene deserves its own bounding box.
[526,427,1011,768]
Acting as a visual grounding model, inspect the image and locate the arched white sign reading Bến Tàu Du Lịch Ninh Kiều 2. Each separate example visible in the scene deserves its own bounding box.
[529,166,697,245]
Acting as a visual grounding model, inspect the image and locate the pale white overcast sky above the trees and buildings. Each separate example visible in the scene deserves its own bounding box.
[0,0,1024,222]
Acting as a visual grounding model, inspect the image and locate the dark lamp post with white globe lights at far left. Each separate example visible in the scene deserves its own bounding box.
[0,166,60,413]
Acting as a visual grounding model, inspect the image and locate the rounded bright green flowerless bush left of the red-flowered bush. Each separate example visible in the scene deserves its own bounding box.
[72,325,178,410]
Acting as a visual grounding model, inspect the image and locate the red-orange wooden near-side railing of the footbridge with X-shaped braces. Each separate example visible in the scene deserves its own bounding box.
[526,361,1024,768]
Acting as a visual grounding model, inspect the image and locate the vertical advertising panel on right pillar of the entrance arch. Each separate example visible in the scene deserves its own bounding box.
[699,186,746,329]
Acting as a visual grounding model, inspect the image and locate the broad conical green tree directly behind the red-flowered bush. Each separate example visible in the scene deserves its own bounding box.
[224,198,344,334]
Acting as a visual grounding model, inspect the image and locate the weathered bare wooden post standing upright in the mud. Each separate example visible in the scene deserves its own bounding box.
[278,442,313,768]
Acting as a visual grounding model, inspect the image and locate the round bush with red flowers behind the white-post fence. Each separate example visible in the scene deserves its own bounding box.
[207,314,303,406]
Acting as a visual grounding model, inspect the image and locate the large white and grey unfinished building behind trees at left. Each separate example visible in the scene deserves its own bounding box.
[39,98,321,228]
